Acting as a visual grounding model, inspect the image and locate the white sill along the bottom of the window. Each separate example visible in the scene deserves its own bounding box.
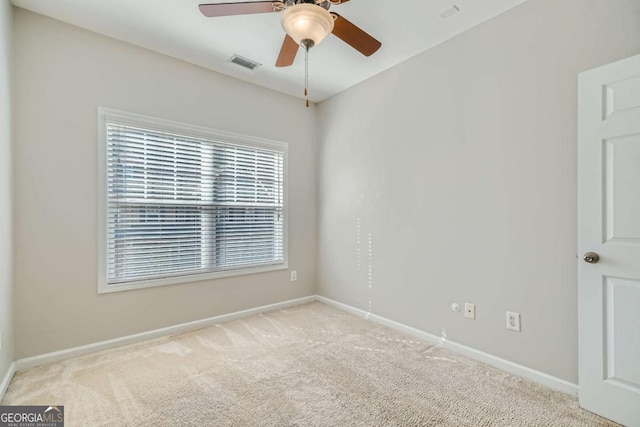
[98,262,289,294]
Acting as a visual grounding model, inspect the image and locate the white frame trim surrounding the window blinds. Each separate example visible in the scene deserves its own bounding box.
[97,107,289,294]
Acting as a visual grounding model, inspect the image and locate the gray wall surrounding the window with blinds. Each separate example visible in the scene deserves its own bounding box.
[13,9,316,358]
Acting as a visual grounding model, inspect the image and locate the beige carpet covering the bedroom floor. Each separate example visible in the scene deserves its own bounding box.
[2,303,615,427]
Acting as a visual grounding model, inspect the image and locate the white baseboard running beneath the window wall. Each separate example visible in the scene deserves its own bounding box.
[15,295,316,372]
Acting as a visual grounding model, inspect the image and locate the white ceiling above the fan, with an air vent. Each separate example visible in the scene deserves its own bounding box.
[13,0,526,102]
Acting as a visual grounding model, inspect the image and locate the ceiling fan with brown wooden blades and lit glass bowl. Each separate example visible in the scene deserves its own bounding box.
[199,0,382,67]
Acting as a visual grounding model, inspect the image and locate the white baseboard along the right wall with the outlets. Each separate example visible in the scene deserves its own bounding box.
[316,295,578,397]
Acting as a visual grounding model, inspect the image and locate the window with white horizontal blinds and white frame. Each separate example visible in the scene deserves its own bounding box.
[99,109,287,292]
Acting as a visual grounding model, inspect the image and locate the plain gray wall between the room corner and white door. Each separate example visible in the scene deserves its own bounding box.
[318,0,640,383]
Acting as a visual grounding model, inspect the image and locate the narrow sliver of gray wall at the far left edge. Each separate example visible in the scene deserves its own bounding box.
[0,1,13,382]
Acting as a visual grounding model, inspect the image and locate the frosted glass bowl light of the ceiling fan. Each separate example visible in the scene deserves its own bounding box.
[281,3,333,47]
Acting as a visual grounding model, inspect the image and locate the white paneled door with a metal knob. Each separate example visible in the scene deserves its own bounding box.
[578,55,640,426]
